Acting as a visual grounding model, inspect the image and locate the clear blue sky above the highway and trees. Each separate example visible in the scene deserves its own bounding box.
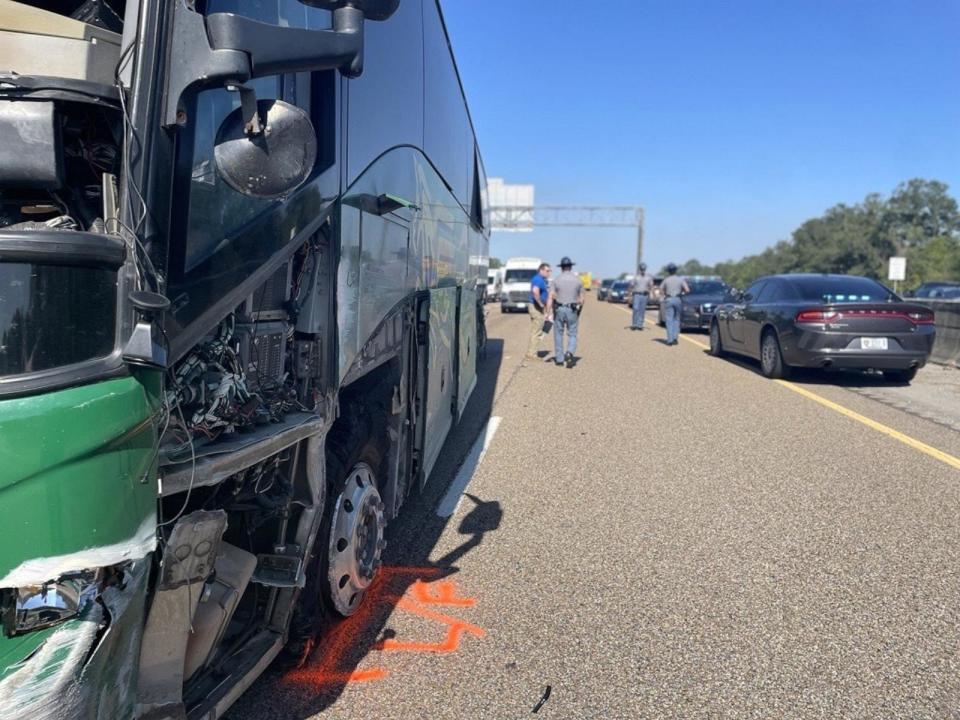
[442,0,960,275]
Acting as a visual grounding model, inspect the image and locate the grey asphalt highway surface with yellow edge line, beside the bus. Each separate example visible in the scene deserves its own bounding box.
[228,300,960,720]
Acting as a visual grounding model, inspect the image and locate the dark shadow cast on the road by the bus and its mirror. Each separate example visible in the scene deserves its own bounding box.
[227,338,504,720]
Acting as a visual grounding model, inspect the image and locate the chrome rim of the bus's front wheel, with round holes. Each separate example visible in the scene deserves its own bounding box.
[327,463,386,615]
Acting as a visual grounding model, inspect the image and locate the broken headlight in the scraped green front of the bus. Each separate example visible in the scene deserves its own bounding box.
[0,570,100,637]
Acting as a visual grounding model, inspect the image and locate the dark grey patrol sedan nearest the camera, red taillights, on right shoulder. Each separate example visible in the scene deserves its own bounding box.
[710,274,935,382]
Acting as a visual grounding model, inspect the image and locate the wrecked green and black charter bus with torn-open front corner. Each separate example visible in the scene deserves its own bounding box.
[0,0,489,720]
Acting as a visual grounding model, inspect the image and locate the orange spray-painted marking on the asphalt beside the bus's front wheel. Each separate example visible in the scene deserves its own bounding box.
[284,567,486,689]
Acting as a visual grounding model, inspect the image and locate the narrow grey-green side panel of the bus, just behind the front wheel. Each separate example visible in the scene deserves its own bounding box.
[423,287,458,478]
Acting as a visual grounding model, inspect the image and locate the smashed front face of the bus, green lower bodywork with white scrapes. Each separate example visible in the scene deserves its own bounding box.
[0,1,162,718]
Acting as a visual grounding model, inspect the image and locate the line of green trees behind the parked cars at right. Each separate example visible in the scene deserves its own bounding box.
[661,178,960,288]
